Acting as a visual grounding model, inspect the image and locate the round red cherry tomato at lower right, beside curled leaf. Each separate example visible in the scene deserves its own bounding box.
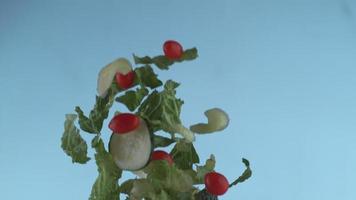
[204,172,229,196]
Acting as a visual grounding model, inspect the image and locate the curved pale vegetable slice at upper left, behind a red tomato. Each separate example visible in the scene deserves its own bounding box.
[97,58,132,97]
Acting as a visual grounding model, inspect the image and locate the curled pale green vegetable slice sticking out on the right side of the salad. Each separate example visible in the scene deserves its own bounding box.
[190,108,229,133]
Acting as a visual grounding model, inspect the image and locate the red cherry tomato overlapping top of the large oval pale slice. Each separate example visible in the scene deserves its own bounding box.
[109,113,140,134]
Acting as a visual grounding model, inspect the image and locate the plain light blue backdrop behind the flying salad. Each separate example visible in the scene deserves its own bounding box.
[0,0,356,200]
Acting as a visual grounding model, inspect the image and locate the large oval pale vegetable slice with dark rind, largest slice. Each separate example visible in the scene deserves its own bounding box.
[109,119,152,171]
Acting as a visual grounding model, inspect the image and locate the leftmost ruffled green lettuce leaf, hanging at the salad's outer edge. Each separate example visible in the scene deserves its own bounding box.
[61,114,90,164]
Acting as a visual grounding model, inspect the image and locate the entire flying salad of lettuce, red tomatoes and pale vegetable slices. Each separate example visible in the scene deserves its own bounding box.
[61,40,252,200]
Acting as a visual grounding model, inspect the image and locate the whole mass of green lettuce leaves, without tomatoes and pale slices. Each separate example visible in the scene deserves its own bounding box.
[61,48,251,200]
